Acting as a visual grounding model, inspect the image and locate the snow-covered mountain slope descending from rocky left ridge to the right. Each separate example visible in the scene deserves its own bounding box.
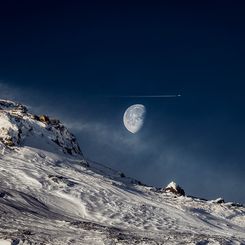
[0,101,245,245]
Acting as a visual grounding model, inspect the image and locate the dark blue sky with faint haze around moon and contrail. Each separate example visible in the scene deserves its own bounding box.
[0,0,245,203]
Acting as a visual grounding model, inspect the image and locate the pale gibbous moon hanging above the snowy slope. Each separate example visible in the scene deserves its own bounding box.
[123,104,146,134]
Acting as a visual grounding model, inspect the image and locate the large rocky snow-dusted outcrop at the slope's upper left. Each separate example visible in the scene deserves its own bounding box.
[0,100,82,155]
